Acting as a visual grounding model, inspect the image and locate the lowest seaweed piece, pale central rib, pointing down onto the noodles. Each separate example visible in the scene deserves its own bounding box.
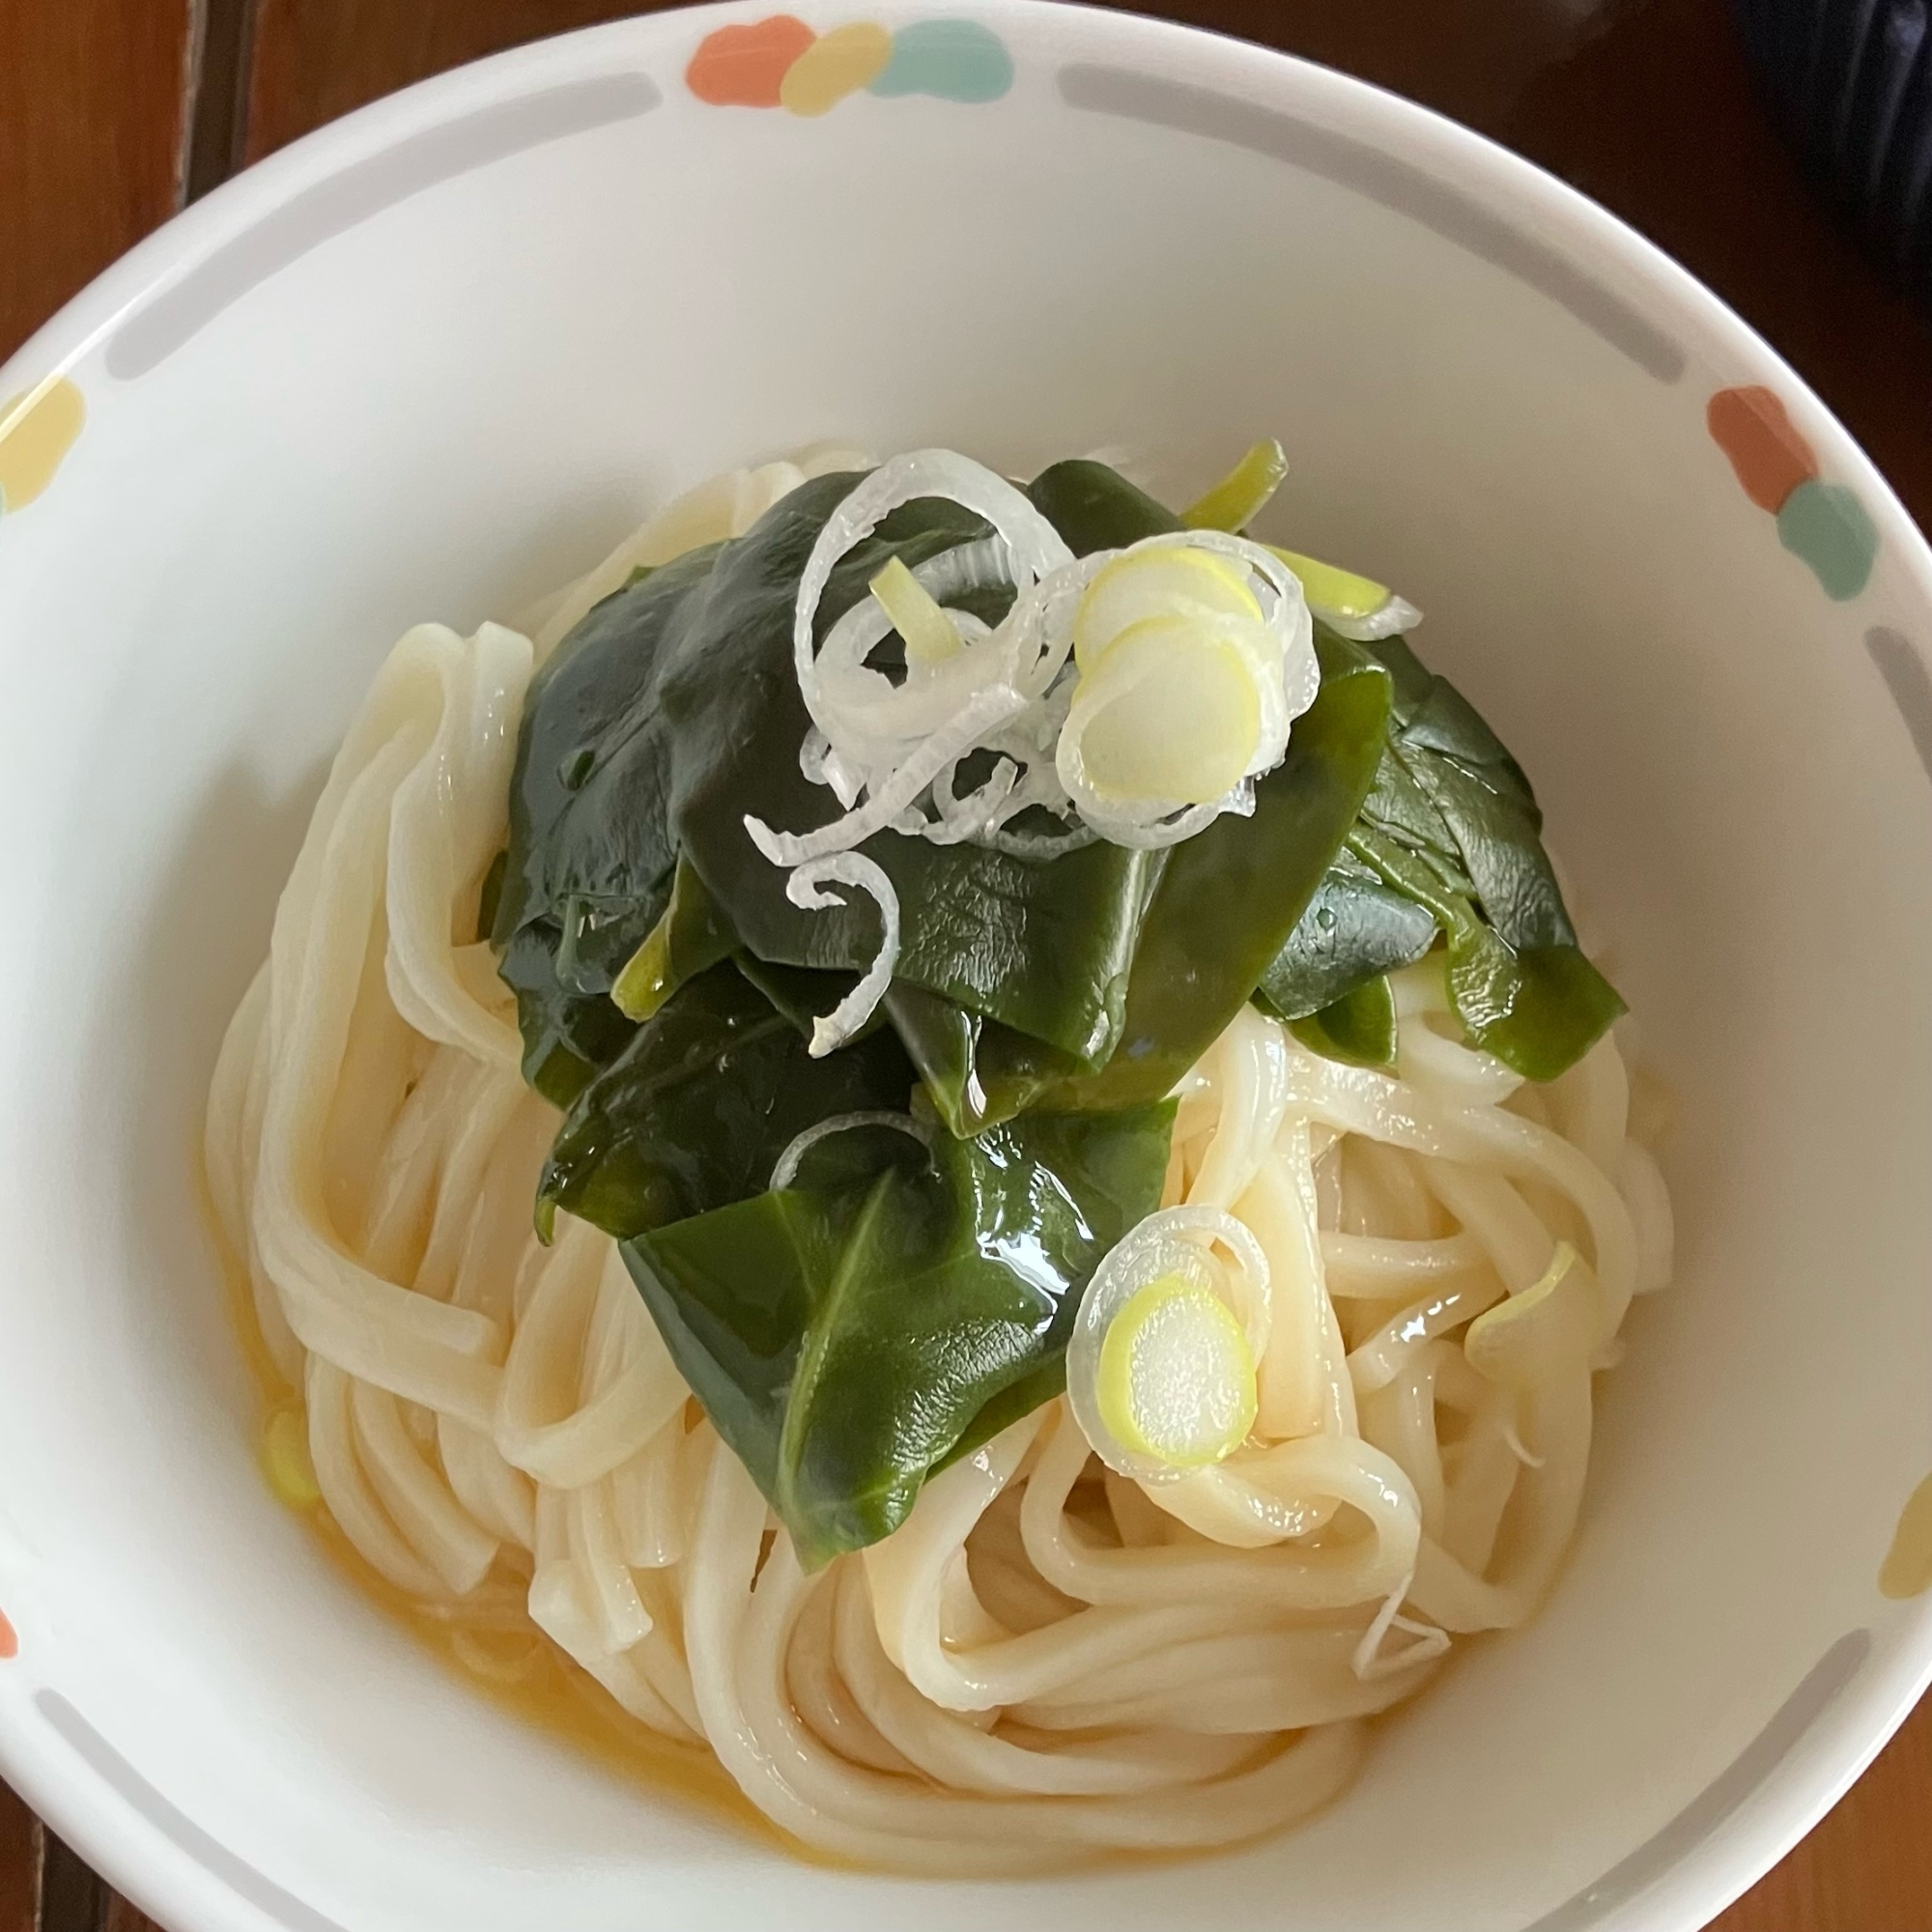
[622,1103,1173,1567]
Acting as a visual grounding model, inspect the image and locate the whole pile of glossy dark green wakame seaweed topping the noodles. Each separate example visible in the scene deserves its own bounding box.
[487,448,1621,1563]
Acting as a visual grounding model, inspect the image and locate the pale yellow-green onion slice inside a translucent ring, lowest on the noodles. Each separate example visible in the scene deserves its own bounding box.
[1095,1275,1256,1470]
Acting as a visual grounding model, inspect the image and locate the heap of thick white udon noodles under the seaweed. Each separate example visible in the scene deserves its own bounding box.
[207,452,1671,1872]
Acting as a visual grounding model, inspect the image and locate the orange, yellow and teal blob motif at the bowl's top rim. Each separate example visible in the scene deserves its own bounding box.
[684,14,1012,120]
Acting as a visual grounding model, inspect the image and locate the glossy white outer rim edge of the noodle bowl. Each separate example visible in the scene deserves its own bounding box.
[0,0,1932,1932]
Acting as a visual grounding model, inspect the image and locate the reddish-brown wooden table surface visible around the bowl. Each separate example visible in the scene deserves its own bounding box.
[0,0,1932,1932]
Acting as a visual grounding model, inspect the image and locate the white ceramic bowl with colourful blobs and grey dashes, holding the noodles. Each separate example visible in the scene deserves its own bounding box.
[0,0,1932,1932]
